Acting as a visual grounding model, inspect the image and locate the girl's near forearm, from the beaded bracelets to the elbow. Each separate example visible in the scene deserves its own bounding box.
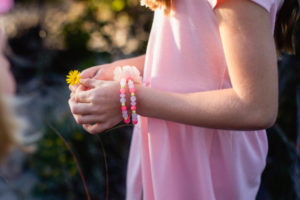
[136,86,276,130]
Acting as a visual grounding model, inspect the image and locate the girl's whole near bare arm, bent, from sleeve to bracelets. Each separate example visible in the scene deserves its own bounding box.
[136,0,278,130]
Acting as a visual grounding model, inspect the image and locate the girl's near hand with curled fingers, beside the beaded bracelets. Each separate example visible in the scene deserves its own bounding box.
[69,79,122,134]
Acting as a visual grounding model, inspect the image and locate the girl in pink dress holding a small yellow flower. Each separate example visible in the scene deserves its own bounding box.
[69,0,298,200]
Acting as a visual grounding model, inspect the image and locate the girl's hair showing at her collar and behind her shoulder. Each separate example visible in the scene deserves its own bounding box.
[142,0,299,53]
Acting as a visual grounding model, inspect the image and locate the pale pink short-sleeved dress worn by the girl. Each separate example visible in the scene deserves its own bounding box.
[126,0,282,200]
